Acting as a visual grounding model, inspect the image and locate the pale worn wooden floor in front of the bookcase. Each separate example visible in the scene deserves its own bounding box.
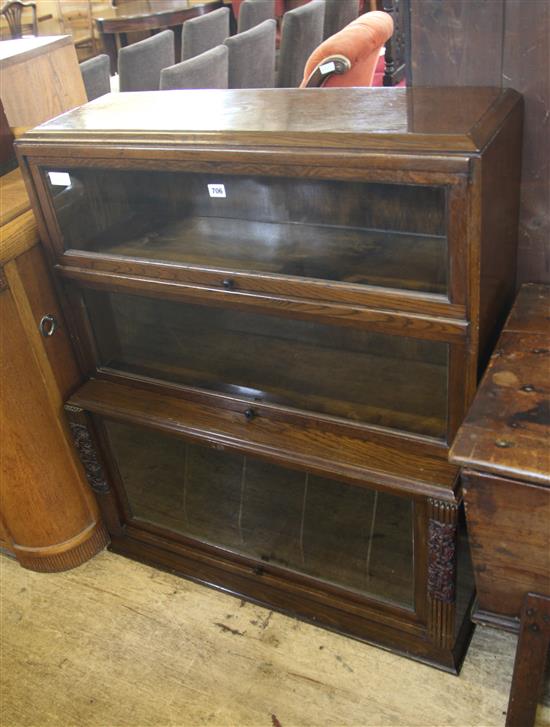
[0,552,550,727]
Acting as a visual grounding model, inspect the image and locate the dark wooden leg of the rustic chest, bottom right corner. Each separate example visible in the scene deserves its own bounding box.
[506,593,550,727]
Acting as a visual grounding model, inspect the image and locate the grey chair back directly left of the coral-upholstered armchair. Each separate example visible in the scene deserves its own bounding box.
[277,0,325,88]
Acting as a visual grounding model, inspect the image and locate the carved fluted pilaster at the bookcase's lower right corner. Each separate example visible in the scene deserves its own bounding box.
[428,498,458,648]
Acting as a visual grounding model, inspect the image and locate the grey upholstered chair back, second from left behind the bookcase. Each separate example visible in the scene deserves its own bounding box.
[118,30,175,91]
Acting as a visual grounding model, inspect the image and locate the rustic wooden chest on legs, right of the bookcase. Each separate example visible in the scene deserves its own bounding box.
[451,284,550,727]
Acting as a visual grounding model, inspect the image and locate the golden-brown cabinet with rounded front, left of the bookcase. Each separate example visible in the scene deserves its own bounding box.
[0,170,108,571]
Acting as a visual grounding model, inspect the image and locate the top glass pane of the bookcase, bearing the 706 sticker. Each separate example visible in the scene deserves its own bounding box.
[45,168,447,294]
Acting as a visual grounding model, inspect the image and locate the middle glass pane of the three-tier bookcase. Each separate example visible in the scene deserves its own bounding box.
[74,288,458,439]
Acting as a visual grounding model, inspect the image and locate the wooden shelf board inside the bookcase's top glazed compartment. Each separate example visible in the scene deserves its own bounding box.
[82,217,447,294]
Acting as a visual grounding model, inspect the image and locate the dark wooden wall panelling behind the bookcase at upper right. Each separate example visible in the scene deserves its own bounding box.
[409,0,550,283]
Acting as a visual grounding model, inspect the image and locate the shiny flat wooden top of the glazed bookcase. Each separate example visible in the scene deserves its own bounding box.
[20,88,519,153]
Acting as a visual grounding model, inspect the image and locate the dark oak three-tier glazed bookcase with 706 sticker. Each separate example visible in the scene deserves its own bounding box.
[19,89,522,671]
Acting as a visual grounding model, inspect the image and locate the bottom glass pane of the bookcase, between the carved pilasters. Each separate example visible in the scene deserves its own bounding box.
[105,421,414,607]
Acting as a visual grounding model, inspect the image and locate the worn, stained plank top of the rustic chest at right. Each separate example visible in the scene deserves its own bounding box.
[451,285,550,487]
